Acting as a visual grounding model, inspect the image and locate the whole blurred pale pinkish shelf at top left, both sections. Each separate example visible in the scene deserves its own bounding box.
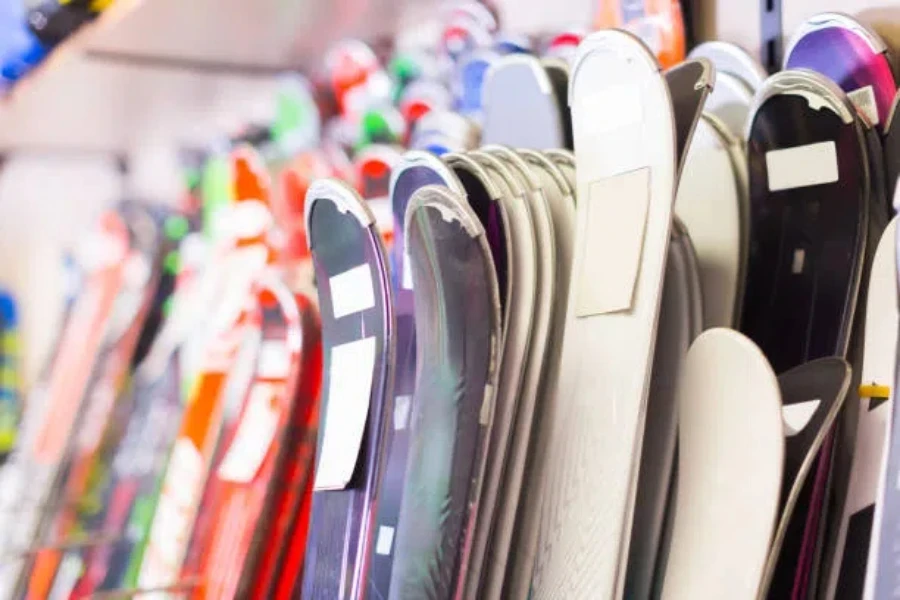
[0,0,436,153]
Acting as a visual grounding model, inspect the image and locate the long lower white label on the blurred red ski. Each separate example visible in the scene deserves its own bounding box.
[218,383,278,483]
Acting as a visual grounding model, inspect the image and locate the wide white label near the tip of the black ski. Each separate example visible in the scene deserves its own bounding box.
[766,142,838,192]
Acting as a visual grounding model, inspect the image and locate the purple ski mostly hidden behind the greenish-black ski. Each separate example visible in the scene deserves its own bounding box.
[367,151,465,598]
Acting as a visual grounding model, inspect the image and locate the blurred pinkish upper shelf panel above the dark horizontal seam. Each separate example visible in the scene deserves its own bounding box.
[86,0,435,71]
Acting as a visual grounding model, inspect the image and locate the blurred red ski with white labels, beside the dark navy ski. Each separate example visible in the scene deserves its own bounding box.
[184,276,322,599]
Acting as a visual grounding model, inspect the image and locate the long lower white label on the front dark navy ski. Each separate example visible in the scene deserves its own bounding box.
[315,337,375,491]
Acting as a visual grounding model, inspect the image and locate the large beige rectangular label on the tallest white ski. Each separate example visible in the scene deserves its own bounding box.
[575,167,650,317]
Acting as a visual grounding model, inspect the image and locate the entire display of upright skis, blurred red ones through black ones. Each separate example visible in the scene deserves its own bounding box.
[0,3,900,600]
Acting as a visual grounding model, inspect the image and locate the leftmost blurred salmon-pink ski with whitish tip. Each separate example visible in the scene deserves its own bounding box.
[0,211,129,599]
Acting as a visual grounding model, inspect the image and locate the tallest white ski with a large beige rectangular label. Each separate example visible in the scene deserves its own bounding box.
[533,30,678,600]
